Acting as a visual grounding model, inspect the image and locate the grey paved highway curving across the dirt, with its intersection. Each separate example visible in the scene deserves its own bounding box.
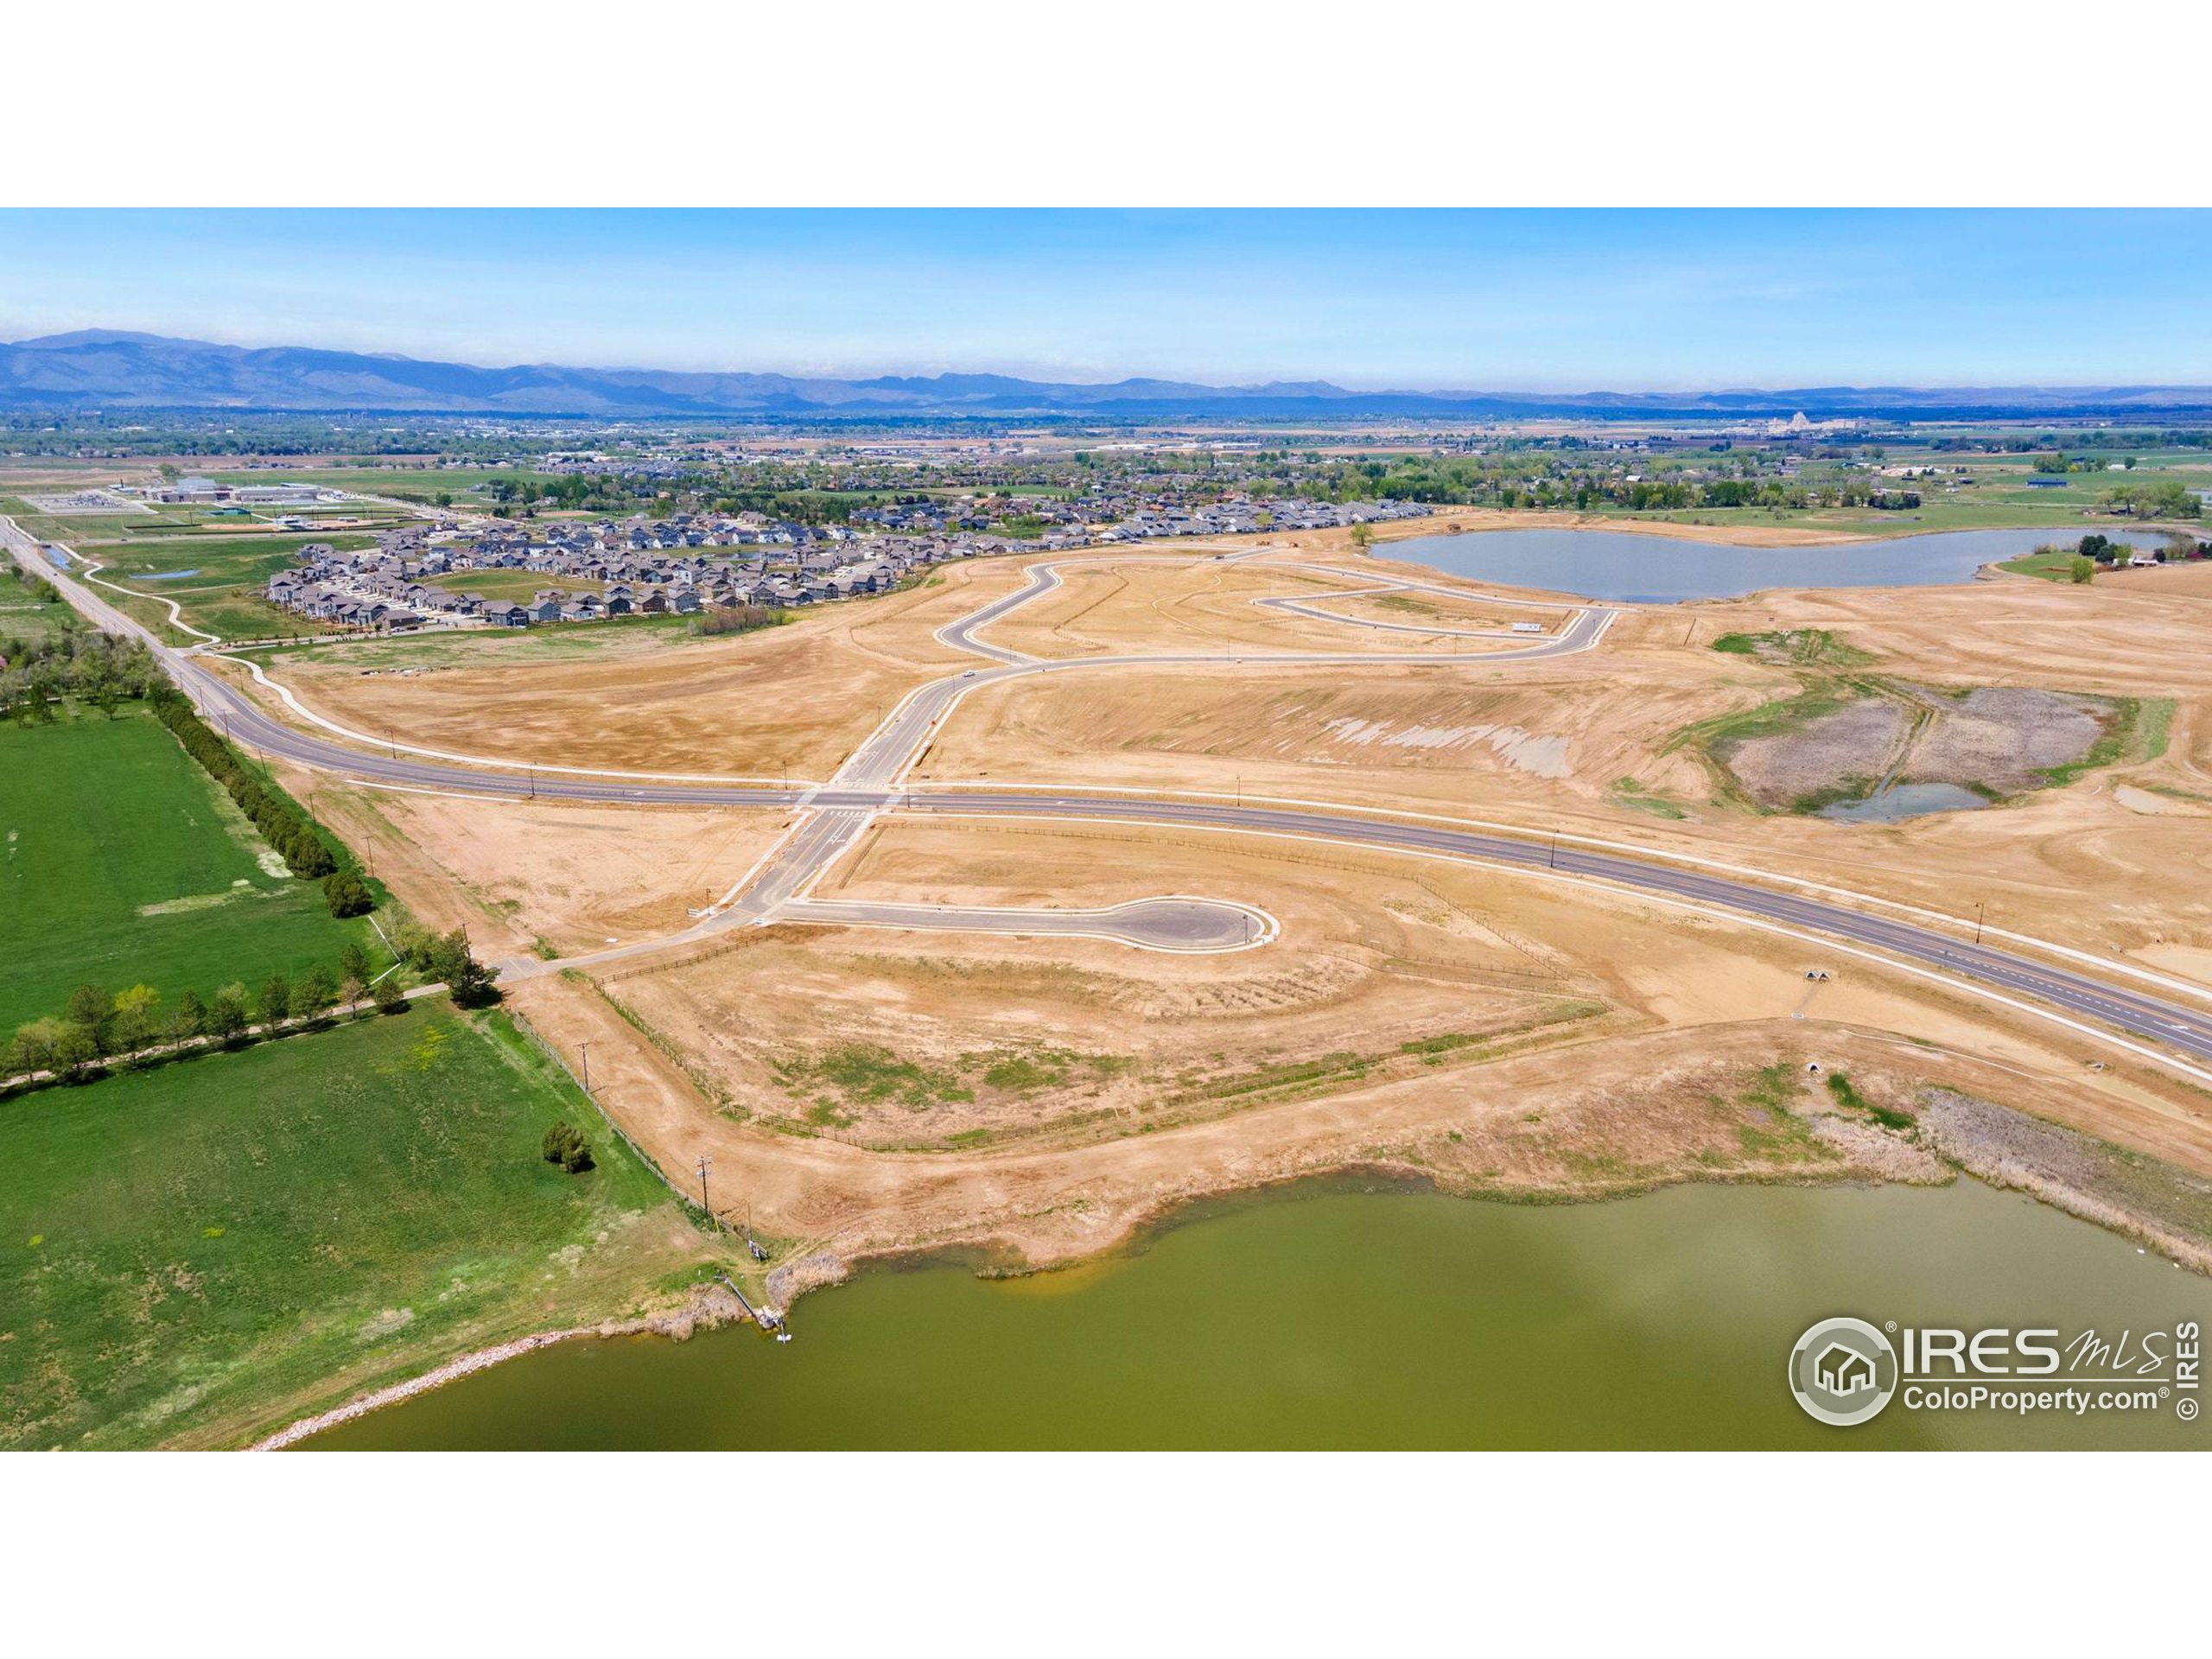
[17,520,2212,1075]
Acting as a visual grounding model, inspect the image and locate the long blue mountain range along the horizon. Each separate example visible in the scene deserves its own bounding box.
[0,329,2212,423]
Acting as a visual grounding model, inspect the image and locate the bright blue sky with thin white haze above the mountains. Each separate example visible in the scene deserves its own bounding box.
[0,210,2212,390]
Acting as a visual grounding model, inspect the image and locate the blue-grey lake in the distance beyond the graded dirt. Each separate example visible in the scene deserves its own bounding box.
[1374,529,2165,604]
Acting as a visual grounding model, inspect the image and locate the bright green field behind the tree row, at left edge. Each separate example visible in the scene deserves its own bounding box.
[0,710,376,1033]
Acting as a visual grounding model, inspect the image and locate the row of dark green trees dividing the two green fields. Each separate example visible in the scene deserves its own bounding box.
[0,925,498,1082]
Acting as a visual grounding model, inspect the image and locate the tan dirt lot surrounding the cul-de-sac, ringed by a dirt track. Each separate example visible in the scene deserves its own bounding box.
[604,821,1621,1146]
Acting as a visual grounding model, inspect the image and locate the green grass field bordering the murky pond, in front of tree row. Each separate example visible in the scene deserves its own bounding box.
[0,1000,708,1446]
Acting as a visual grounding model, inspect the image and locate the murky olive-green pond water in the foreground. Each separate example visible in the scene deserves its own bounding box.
[308,1181,2212,1449]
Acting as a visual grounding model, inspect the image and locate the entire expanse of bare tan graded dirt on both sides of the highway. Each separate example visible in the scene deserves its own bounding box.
[203,515,2212,1261]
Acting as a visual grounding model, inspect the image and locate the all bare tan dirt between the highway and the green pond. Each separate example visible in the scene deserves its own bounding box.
[535,821,2212,1255]
